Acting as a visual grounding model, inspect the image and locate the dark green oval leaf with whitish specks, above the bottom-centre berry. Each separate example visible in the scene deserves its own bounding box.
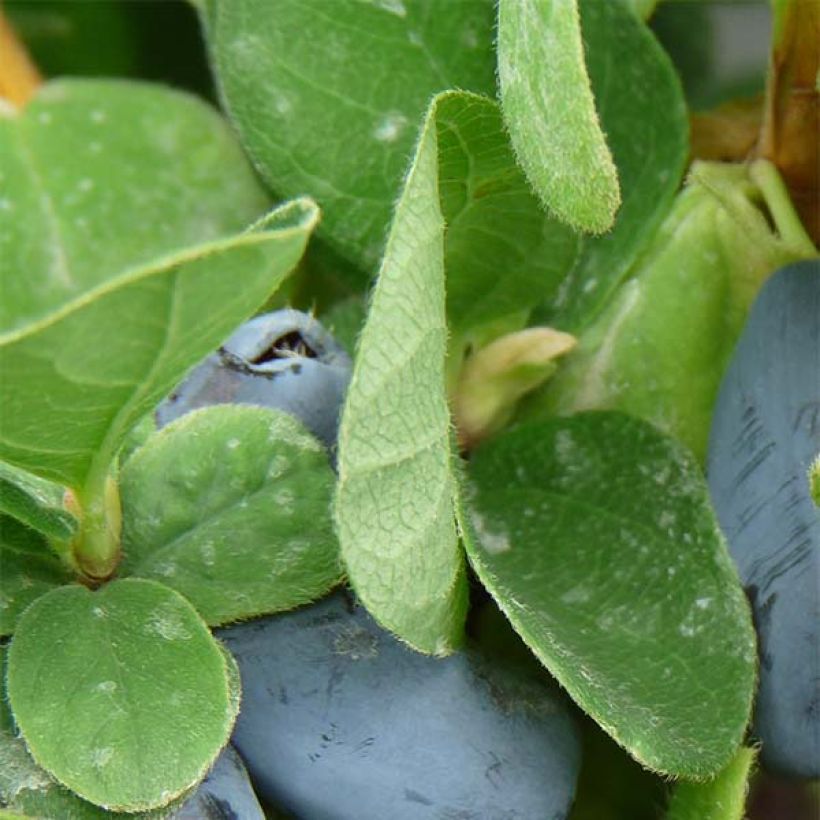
[460,413,756,778]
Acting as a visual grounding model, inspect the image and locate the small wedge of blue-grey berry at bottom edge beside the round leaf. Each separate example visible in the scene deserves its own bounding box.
[173,745,265,820]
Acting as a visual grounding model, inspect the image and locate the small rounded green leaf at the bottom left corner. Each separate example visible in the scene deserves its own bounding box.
[8,579,236,811]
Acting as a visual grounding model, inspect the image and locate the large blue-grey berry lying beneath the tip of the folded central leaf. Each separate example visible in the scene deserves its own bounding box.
[218,591,580,820]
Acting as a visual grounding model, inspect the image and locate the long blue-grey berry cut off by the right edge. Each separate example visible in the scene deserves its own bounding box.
[708,260,820,778]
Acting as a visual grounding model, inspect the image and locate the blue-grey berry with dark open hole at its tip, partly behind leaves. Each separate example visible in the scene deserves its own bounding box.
[156,309,351,447]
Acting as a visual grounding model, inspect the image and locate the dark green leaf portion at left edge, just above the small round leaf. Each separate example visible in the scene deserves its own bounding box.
[0,515,72,635]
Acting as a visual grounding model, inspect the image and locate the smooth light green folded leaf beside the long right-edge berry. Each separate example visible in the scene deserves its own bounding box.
[529,163,815,460]
